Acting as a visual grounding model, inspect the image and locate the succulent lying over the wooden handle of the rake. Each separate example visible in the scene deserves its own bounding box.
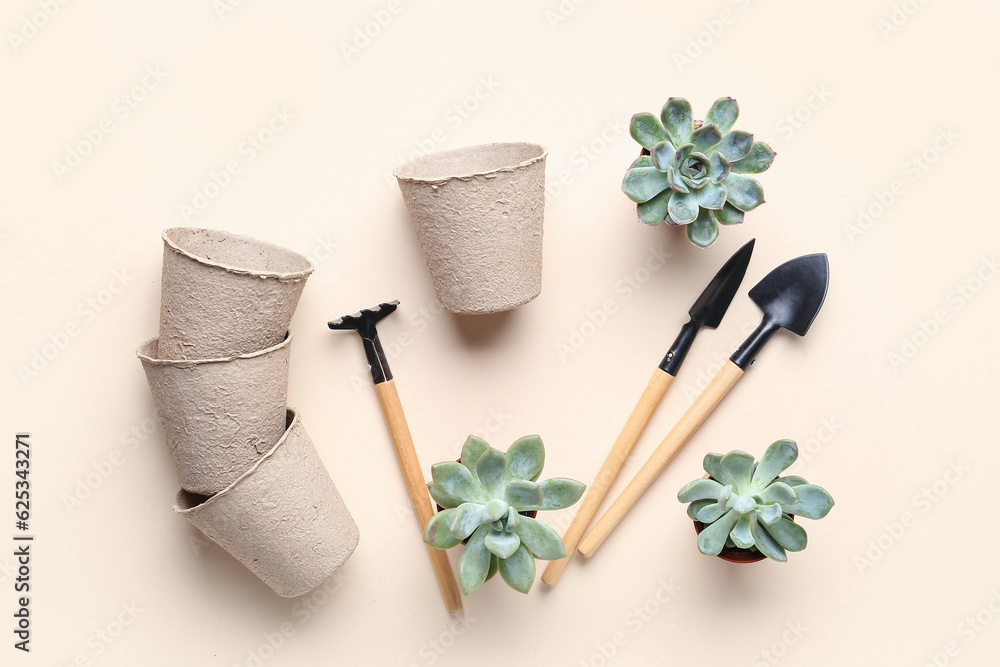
[424,435,586,595]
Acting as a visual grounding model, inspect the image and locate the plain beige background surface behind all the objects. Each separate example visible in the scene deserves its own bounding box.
[0,0,1000,666]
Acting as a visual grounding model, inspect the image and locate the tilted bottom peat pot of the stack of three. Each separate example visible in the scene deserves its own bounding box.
[174,409,359,597]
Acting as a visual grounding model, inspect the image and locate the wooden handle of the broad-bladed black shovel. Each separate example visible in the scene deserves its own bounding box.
[579,361,743,558]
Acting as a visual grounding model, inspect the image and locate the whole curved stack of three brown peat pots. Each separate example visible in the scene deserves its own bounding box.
[137,227,358,597]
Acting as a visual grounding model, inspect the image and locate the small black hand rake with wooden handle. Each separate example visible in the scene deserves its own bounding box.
[329,301,462,612]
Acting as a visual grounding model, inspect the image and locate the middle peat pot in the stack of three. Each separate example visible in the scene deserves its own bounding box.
[136,336,292,495]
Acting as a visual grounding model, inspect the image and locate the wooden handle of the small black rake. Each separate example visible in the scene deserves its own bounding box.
[375,380,462,612]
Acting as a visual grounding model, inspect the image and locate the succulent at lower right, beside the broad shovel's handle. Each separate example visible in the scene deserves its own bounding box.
[677,440,833,561]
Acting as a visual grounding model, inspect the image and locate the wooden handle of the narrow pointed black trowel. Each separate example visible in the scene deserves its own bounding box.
[542,368,674,586]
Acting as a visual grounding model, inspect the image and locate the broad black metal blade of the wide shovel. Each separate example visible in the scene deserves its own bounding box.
[750,253,830,336]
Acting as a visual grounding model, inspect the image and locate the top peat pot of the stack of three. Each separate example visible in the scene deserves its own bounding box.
[159,227,314,359]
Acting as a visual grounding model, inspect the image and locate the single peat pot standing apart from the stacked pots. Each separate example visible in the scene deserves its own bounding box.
[393,143,546,313]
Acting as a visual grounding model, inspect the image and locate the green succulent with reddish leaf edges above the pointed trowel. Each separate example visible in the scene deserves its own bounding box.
[622,97,775,248]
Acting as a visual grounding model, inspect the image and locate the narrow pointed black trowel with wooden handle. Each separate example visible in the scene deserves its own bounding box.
[542,239,754,586]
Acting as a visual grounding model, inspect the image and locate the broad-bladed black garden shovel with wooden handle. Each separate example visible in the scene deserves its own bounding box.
[578,254,830,558]
